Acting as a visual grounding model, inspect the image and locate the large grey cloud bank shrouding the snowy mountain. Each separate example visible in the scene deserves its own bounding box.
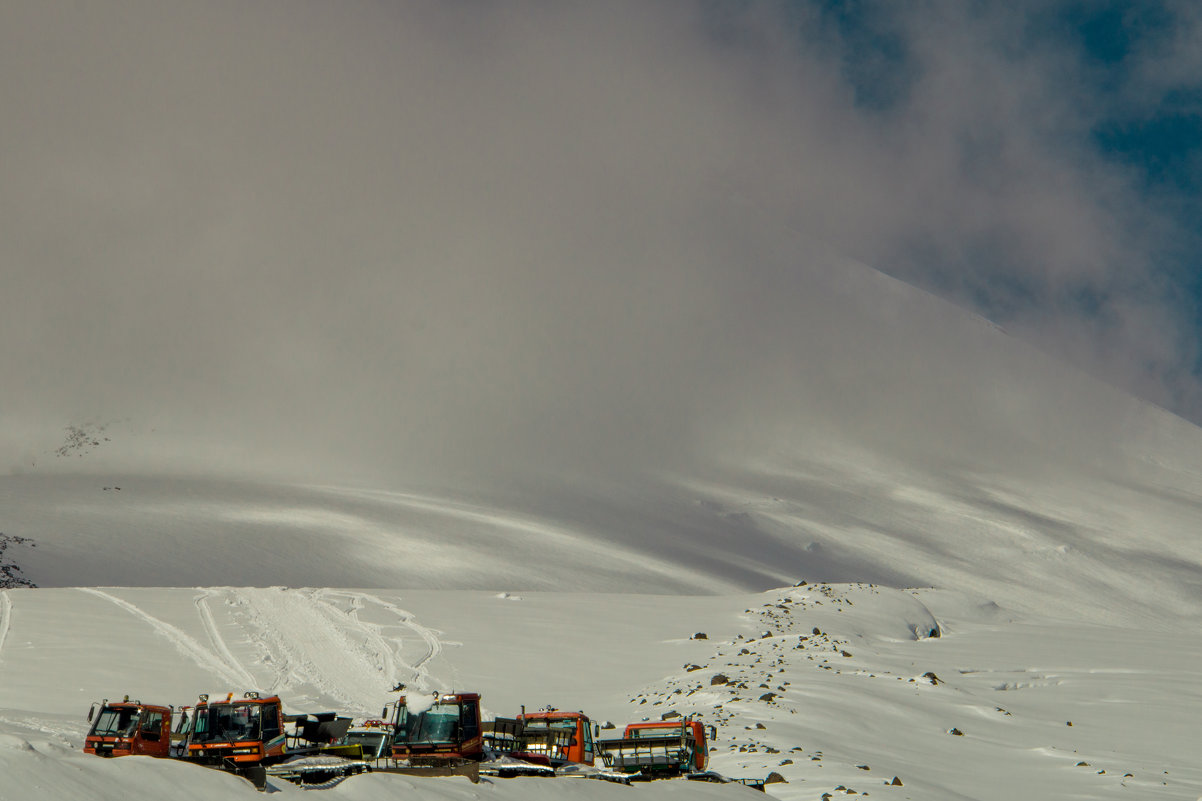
[0,0,1197,483]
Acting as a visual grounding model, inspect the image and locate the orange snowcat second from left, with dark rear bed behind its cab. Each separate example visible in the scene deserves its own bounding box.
[182,692,368,790]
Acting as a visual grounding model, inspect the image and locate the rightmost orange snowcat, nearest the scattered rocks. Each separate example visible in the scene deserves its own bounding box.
[597,718,718,779]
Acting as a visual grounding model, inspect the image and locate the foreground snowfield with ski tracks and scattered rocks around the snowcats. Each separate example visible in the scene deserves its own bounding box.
[0,585,1202,801]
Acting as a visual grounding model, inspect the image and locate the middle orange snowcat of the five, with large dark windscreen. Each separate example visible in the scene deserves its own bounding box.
[373,684,484,783]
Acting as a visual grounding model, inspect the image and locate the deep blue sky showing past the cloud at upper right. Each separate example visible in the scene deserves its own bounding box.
[807,0,1202,411]
